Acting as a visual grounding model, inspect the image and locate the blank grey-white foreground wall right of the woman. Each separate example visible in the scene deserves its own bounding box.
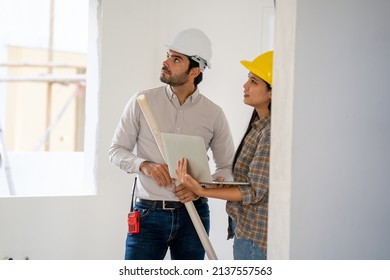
[269,0,390,259]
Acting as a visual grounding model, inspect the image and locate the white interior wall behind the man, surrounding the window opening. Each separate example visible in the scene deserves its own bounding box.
[0,0,273,259]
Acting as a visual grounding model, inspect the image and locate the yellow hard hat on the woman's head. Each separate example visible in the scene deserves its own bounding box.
[241,51,274,87]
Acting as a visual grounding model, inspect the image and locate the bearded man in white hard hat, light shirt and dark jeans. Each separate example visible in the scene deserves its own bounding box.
[109,28,234,260]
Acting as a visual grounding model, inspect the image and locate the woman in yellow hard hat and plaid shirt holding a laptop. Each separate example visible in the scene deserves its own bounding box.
[176,51,273,260]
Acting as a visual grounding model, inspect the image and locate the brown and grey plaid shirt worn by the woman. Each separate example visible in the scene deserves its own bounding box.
[226,116,271,255]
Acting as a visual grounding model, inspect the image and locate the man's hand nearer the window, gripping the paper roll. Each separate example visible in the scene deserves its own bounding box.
[139,161,175,187]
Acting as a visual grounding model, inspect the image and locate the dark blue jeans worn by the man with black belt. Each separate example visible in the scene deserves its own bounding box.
[125,202,210,260]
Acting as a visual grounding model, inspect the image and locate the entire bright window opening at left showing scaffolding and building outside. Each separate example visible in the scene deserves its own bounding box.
[0,0,88,196]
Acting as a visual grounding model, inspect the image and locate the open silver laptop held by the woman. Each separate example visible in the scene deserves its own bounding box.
[161,133,249,185]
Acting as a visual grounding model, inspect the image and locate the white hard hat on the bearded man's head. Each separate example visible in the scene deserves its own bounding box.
[165,28,212,72]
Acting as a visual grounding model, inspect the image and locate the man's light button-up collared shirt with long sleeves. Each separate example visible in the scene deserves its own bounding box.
[109,85,234,200]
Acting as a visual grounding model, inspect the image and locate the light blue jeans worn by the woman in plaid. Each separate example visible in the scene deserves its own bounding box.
[229,219,267,260]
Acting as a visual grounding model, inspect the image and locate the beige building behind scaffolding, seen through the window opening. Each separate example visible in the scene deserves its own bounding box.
[0,47,86,152]
